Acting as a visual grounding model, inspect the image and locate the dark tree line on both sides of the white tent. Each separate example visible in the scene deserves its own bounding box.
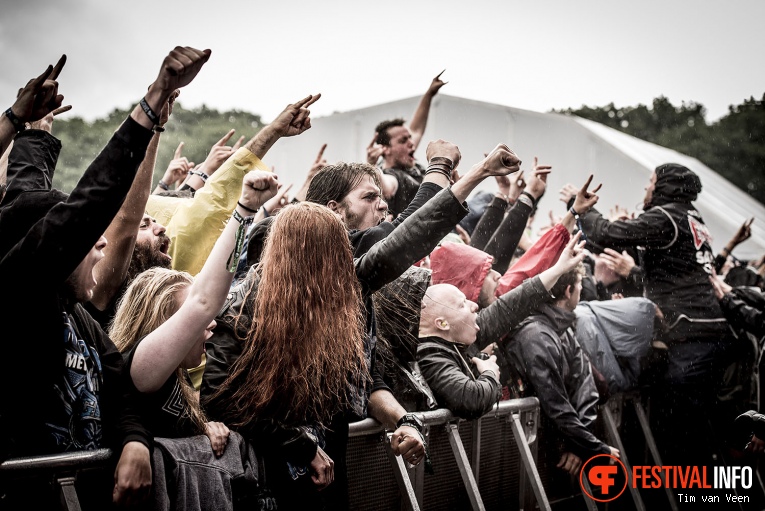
[53,94,765,207]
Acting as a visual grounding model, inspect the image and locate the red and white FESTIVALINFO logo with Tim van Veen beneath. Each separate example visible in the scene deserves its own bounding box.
[579,454,753,502]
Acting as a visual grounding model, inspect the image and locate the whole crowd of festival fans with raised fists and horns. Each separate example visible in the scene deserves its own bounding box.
[0,47,765,509]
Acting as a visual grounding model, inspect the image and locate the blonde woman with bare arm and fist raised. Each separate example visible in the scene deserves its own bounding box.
[109,171,278,456]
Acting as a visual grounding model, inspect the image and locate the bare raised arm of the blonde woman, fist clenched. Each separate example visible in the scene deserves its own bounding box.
[130,171,278,392]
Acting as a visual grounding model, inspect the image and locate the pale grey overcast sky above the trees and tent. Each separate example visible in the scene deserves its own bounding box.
[0,0,765,121]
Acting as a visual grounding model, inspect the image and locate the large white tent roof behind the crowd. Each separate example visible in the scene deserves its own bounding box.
[266,94,765,259]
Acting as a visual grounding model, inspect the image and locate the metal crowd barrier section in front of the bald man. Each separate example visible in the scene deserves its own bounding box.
[347,397,550,511]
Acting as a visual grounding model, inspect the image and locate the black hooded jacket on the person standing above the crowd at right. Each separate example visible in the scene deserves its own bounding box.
[581,163,728,341]
